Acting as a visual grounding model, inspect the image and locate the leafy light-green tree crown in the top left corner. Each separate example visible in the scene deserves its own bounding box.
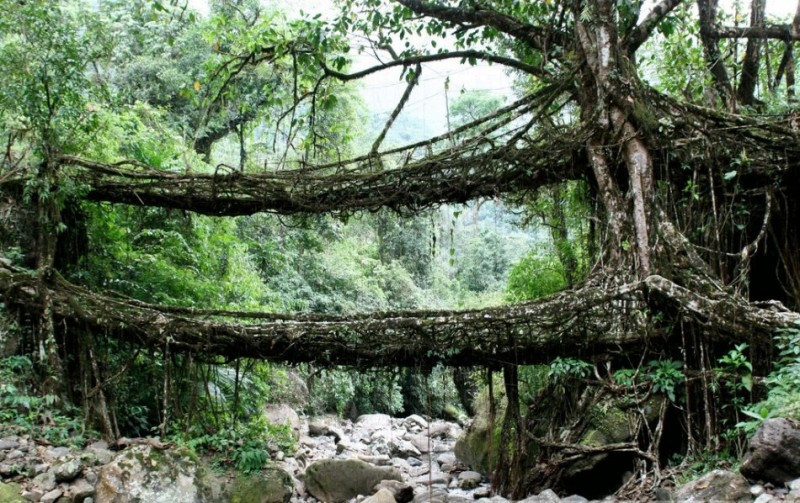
[0,0,106,157]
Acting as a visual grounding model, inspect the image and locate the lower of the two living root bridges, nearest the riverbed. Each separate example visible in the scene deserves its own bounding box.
[0,262,800,367]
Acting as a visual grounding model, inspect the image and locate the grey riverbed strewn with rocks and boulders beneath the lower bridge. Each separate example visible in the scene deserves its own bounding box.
[0,414,800,503]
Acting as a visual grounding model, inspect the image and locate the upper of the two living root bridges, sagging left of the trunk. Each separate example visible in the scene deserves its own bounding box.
[61,140,587,216]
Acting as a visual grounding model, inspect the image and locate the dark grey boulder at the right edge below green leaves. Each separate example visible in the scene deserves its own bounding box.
[740,418,800,485]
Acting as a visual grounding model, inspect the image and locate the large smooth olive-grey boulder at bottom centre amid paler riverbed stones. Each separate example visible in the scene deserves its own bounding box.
[304,460,402,503]
